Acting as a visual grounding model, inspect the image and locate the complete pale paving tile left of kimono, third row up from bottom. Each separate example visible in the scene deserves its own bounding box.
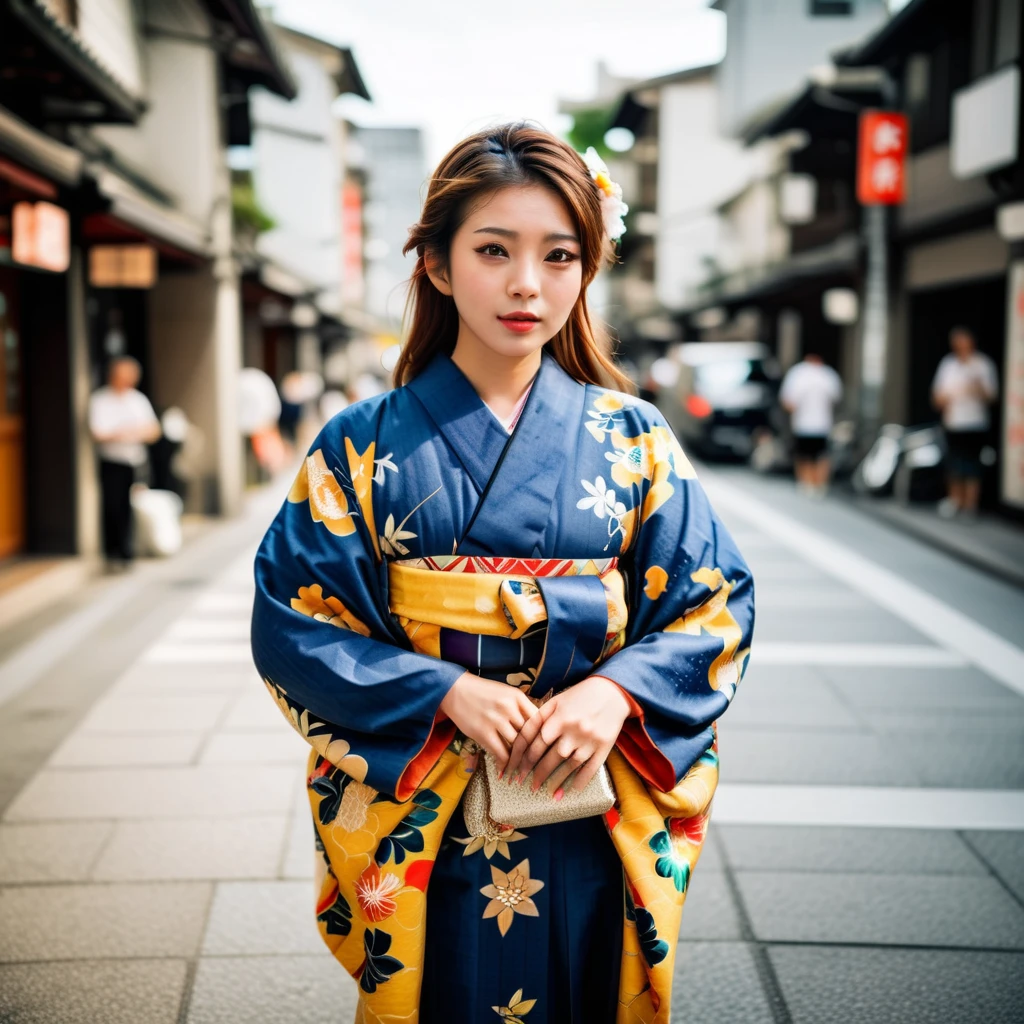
[93,814,288,882]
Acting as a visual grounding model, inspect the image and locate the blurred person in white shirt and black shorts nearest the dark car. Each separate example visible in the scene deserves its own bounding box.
[779,352,843,498]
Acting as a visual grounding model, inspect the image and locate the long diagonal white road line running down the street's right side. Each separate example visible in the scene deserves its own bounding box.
[707,473,1024,695]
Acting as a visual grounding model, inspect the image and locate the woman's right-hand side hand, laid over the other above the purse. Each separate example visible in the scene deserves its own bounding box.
[499,676,630,800]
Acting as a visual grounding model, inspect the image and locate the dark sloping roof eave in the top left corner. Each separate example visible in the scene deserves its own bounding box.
[0,0,145,124]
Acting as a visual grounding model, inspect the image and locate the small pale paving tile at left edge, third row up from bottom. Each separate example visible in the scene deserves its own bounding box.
[0,821,114,884]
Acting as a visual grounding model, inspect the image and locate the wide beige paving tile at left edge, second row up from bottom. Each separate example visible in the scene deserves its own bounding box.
[0,882,211,963]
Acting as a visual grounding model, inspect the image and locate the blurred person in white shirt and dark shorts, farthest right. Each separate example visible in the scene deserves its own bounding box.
[932,327,999,518]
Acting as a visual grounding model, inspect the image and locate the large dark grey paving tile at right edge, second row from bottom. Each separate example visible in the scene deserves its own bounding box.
[736,871,1024,949]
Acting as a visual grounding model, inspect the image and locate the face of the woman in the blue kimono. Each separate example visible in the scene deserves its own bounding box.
[430,185,583,358]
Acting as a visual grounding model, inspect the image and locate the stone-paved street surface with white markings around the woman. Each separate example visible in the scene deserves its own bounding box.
[0,468,1024,1024]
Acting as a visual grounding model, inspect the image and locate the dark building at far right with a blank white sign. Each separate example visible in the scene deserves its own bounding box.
[836,0,1024,511]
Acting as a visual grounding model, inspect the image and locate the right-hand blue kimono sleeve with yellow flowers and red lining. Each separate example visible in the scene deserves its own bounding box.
[595,410,754,792]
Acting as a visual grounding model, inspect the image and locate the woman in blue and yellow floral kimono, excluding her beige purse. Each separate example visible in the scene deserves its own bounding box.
[252,124,754,1024]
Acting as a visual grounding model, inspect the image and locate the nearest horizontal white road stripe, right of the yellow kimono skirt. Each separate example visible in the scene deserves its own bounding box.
[712,782,1024,831]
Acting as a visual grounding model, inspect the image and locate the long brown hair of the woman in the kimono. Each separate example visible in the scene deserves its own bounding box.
[394,122,633,391]
